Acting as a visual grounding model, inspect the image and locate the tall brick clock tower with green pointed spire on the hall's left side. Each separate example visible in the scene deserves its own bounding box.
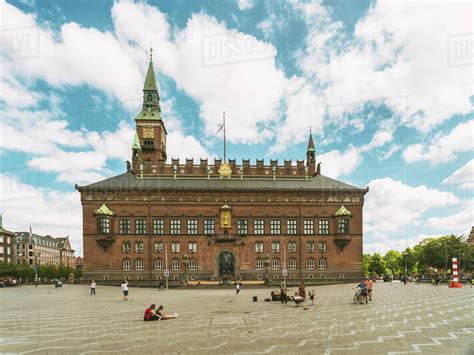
[132,49,167,175]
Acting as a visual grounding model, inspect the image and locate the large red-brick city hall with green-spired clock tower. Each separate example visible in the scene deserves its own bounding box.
[76,54,368,283]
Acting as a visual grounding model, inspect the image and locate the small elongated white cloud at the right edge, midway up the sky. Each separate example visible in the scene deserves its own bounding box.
[403,120,474,165]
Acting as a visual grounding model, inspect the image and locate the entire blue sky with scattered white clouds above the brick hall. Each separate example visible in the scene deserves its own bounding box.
[0,0,474,255]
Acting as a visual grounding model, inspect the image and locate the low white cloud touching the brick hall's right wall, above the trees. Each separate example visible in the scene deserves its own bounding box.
[364,177,460,233]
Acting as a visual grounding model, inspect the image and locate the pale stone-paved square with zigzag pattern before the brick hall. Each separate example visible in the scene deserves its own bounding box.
[0,283,474,354]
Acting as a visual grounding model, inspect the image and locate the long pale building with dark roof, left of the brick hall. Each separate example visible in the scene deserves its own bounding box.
[14,232,76,269]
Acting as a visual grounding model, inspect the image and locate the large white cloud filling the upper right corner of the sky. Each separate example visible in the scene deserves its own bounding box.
[296,1,473,132]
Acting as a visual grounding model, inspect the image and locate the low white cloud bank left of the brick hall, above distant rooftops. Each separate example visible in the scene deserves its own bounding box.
[0,174,82,255]
